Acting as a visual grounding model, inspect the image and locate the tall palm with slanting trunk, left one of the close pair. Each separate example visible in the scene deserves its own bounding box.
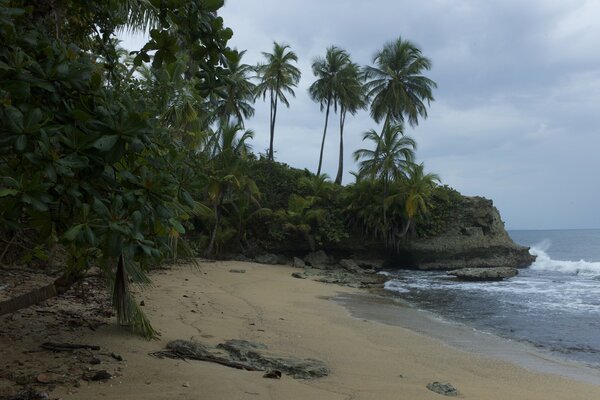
[308,46,350,176]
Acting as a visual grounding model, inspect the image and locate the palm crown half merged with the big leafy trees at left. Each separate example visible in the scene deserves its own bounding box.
[213,50,256,128]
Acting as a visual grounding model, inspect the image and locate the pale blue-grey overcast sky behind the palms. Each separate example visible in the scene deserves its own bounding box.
[125,0,600,229]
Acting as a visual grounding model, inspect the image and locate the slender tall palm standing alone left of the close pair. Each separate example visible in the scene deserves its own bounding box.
[256,42,300,161]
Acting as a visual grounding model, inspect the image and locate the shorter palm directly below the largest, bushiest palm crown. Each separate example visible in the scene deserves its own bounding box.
[354,124,417,227]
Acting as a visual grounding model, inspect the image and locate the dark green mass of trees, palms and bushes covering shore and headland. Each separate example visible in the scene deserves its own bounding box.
[0,0,460,336]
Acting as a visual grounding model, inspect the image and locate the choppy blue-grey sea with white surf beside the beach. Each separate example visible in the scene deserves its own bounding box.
[385,230,600,367]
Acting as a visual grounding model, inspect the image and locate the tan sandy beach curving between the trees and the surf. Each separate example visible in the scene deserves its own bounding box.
[2,262,600,400]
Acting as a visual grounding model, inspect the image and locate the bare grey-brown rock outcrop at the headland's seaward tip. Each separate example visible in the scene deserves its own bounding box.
[393,197,535,270]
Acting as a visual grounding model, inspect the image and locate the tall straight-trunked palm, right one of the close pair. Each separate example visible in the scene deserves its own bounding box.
[335,62,367,185]
